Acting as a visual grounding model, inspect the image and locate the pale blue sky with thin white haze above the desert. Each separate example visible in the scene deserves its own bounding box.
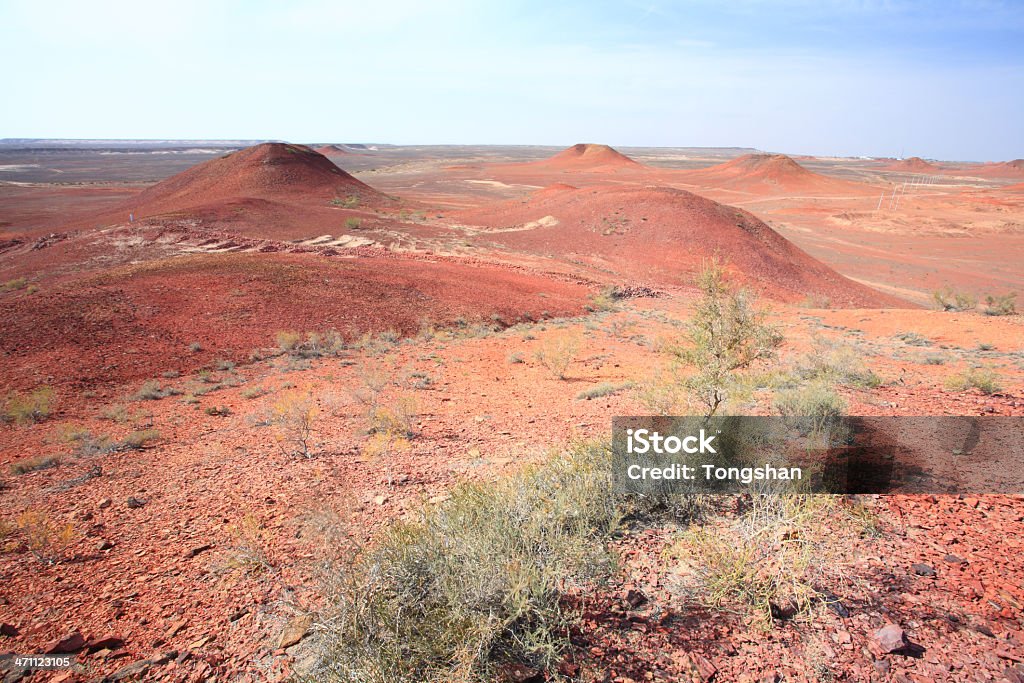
[0,0,1024,160]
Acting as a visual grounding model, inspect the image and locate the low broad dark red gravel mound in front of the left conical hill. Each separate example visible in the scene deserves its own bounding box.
[0,254,591,394]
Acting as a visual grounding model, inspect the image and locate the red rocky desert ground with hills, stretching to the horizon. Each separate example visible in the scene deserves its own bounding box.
[0,141,1024,683]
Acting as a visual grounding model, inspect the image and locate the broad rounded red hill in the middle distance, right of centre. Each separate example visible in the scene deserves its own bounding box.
[457,187,908,307]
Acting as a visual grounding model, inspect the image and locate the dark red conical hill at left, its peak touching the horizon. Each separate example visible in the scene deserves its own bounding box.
[130,142,384,217]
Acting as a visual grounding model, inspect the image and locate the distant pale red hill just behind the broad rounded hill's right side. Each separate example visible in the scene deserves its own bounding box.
[681,154,867,194]
